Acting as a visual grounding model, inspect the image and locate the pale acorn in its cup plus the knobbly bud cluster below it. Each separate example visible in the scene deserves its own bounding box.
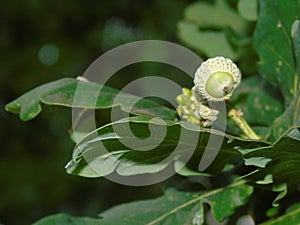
[176,56,241,127]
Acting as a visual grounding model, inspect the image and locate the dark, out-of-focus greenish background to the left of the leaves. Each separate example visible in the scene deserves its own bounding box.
[0,0,193,225]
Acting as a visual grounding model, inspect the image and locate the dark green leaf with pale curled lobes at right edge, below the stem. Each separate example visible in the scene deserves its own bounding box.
[240,128,300,185]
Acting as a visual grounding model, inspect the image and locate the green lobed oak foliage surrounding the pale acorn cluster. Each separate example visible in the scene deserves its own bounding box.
[2,0,300,225]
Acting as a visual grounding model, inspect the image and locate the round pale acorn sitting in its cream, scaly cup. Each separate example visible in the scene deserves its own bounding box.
[194,56,241,101]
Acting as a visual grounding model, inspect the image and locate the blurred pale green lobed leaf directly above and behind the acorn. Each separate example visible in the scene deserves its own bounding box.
[178,0,248,60]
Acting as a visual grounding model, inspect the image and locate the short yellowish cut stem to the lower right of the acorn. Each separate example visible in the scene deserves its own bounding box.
[228,109,261,139]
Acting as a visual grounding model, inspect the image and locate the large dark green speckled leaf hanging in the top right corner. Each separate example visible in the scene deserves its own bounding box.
[254,0,300,107]
